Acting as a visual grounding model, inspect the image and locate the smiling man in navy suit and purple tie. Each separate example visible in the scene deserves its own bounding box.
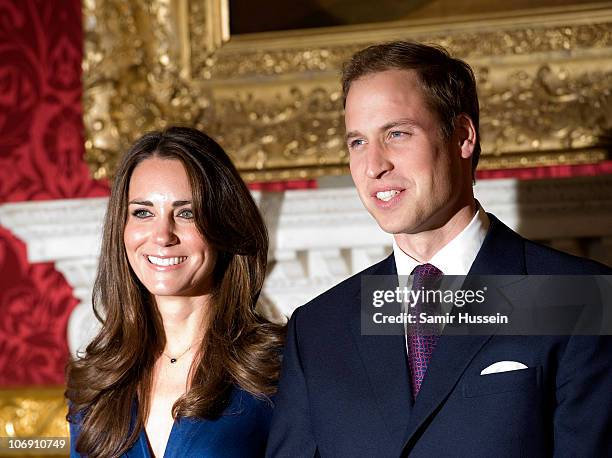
[267,42,612,457]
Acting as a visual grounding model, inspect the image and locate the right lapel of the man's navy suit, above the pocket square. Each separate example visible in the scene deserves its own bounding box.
[405,214,525,451]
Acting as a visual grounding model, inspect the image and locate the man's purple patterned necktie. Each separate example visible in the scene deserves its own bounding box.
[408,264,443,399]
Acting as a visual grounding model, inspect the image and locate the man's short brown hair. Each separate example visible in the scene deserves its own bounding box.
[342,41,480,174]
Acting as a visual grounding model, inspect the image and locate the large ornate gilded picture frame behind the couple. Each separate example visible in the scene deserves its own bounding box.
[83,0,612,181]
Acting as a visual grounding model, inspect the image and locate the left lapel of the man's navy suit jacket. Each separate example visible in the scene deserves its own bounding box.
[350,255,412,448]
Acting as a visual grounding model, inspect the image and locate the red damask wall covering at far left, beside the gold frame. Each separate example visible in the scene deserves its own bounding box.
[0,0,108,386]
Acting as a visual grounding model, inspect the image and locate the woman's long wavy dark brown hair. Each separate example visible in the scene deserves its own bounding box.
[66,127,284,458]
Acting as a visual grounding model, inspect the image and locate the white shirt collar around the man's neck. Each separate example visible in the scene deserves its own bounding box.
[393,204,490,275]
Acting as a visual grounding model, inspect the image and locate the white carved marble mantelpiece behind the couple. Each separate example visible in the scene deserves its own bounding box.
[0,176,612,351]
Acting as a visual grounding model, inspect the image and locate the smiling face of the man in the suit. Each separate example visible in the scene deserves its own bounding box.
[345,70,466,238]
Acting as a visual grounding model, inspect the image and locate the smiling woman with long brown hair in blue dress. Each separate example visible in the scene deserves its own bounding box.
[66,127,283,457]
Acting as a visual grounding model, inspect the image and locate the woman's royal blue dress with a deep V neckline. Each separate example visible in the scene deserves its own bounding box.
[70,388,272,458]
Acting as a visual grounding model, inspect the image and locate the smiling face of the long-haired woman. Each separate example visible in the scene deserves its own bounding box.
[123,157,217,296]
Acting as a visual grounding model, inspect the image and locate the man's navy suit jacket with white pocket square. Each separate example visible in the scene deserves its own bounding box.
[267,215,612,458]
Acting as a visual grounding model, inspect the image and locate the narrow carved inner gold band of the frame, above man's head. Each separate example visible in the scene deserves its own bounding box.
[194,23,612,79]
